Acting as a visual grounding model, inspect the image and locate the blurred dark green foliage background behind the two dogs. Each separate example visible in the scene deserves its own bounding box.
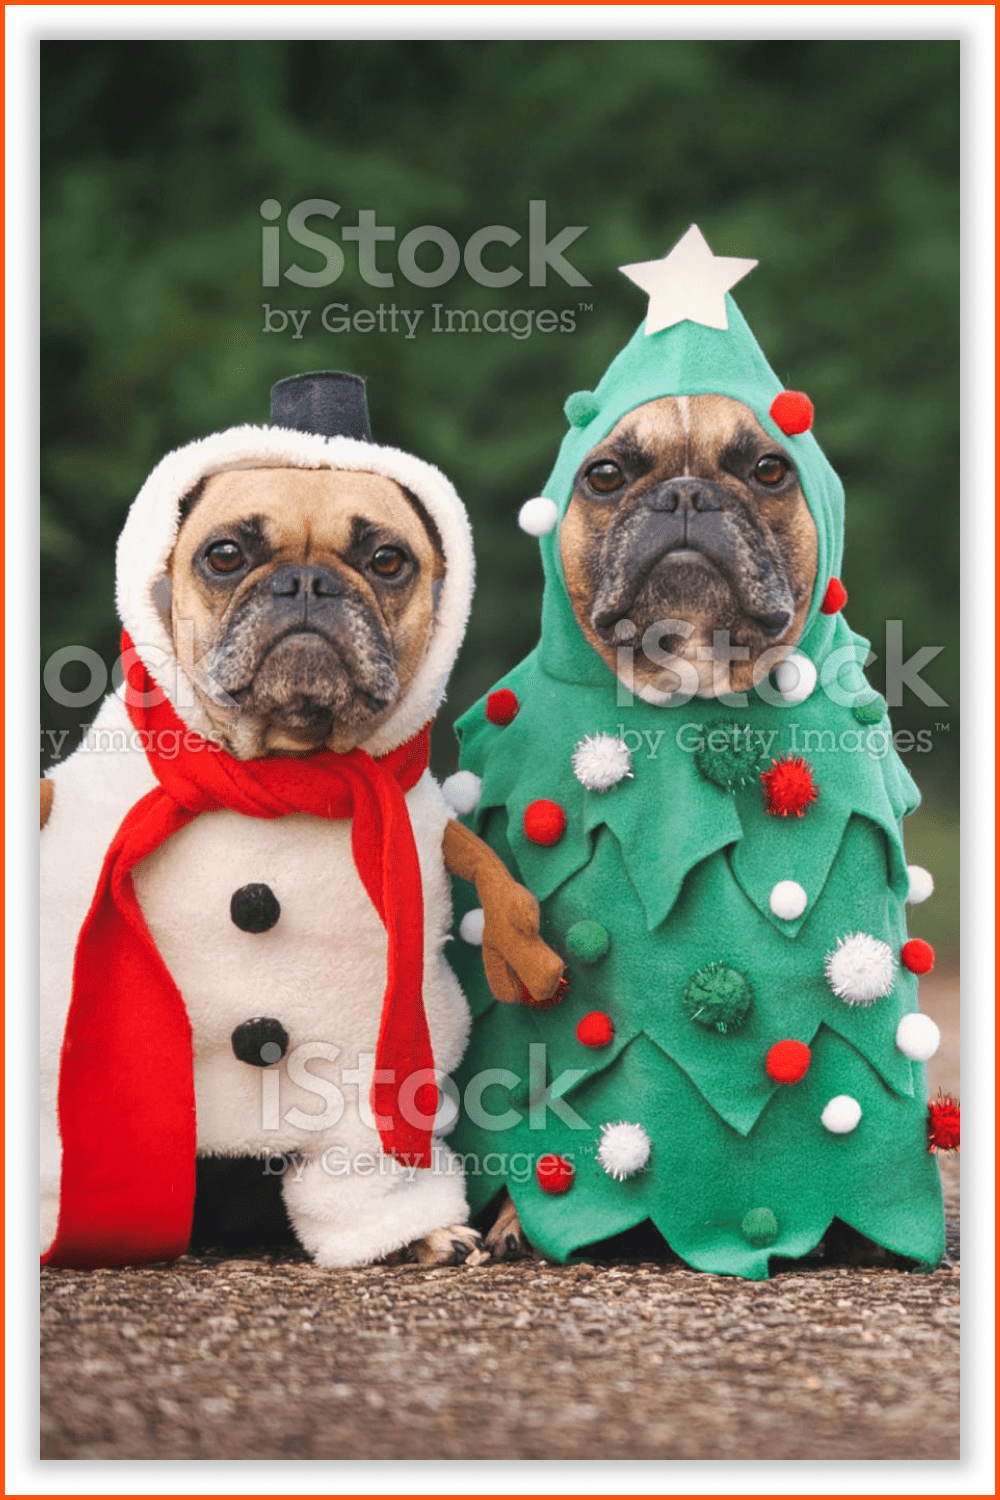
[40,41,960,945]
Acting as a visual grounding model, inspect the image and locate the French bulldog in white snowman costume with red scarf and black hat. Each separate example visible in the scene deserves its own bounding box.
[40,372,562,1266]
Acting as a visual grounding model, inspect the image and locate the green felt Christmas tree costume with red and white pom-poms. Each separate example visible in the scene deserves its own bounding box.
[451,231,945,1278]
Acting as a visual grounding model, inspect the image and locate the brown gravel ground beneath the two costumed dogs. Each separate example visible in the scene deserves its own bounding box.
[40,981,960,1460]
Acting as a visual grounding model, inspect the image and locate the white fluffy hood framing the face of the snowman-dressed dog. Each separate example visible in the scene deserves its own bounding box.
[115,425,474,755]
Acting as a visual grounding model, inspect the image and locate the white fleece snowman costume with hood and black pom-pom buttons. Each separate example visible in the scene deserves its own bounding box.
[40,396,474,1266]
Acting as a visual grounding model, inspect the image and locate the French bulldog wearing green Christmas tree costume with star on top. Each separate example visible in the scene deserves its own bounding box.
[451,227,954,1278]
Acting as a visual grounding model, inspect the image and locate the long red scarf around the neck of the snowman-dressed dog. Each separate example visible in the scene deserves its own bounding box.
[43,633,436,1268]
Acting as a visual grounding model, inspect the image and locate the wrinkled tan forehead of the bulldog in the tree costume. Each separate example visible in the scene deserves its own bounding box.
[582,396,787,479]
